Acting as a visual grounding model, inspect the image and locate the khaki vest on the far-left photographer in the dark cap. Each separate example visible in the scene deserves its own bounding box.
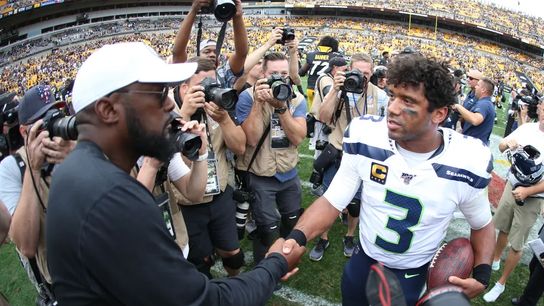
[17,146,52,284]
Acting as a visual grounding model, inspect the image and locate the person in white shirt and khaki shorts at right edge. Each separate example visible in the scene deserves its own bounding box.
[484,103,544,302]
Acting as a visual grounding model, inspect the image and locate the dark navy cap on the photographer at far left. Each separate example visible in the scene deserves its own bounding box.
[18,85,65,125]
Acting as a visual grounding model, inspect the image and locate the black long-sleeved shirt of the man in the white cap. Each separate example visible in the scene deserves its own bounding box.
[46,141,287,306]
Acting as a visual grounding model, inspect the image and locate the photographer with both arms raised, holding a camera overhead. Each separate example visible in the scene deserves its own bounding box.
[172,0,249,88]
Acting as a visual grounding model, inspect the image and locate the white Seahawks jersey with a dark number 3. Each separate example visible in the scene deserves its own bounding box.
[324,116,493,269]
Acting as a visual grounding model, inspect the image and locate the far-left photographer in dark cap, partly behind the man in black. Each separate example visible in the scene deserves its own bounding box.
[0,85,74,300]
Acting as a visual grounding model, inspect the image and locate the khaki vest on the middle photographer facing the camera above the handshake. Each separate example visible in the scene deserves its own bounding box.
[236,87,304,177]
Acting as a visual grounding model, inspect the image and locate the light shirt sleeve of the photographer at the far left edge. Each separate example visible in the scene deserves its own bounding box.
[0,155,23,216]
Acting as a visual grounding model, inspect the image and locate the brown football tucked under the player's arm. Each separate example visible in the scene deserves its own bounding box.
[427,238,474,290]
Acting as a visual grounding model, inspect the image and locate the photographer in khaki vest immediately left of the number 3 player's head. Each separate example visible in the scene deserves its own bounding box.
[310,53,389,260]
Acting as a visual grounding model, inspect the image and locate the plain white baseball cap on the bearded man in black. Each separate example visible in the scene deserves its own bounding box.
[72,42,197,113]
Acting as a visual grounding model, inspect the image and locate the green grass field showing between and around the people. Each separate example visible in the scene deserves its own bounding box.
[0,80,544,306]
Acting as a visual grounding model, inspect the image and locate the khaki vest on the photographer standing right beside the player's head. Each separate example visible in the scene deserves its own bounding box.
[325,83,379,150]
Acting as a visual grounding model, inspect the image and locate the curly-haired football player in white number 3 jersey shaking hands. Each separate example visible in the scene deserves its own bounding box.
[283,53,495,305]
